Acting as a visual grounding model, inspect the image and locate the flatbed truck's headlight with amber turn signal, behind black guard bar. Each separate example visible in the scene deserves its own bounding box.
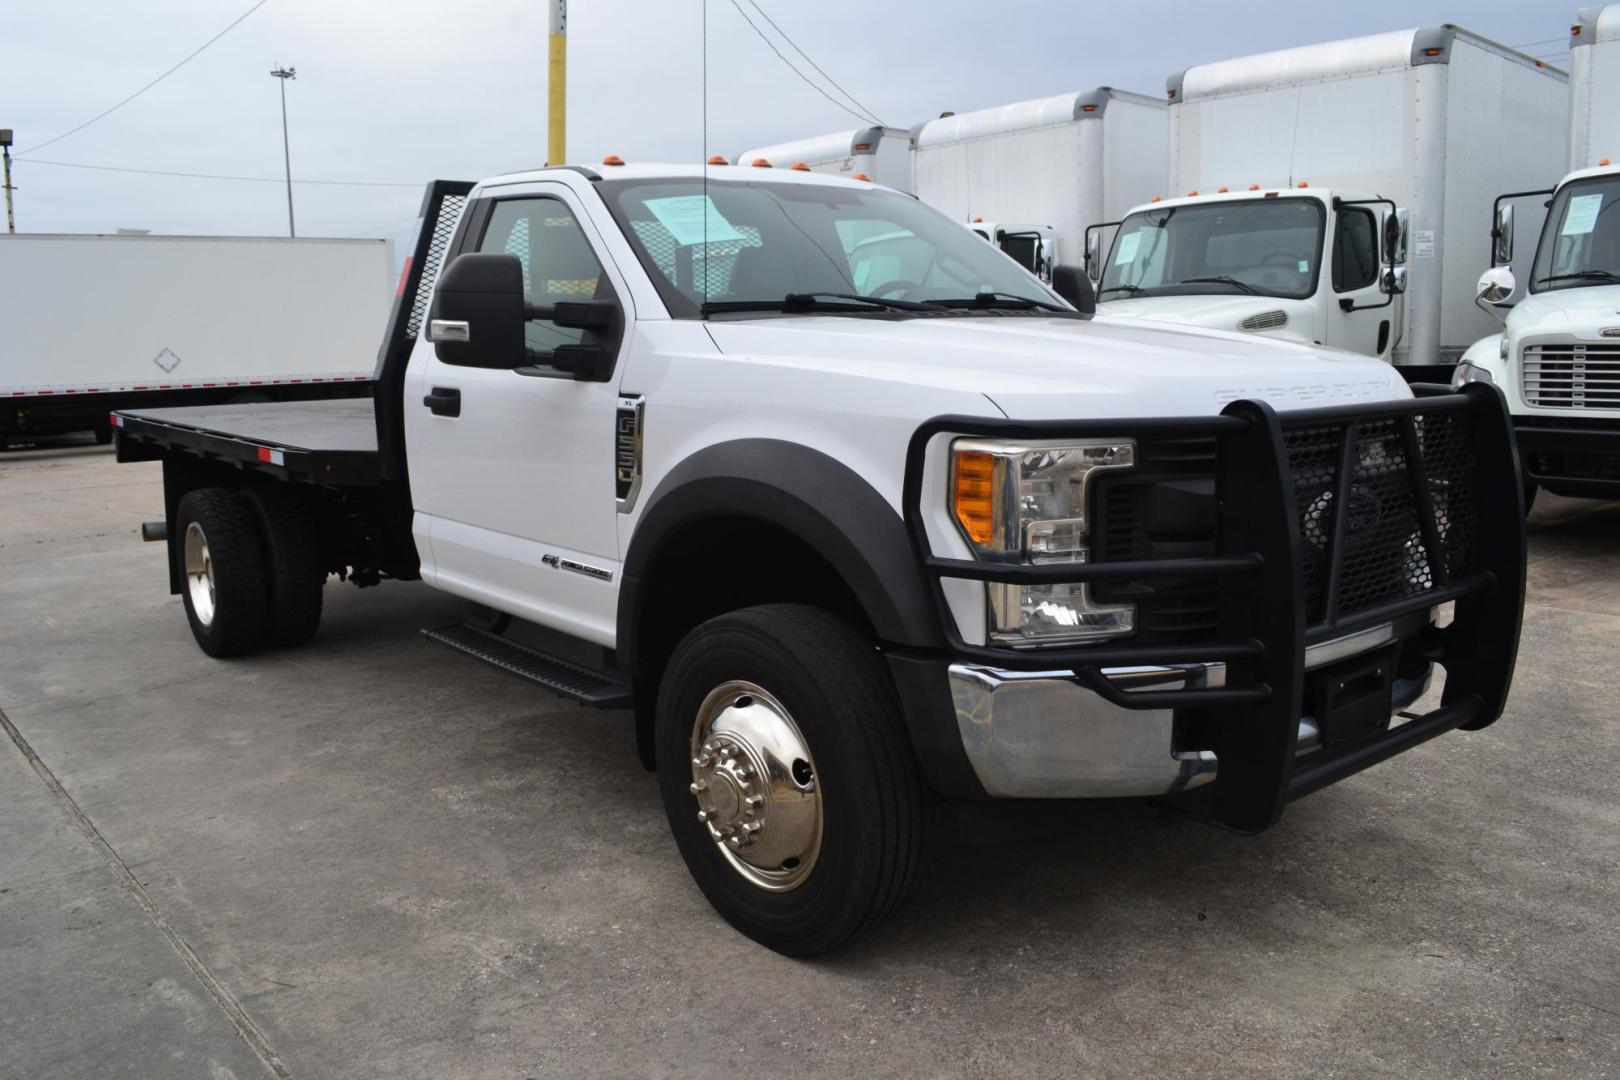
[951,439,1136,644]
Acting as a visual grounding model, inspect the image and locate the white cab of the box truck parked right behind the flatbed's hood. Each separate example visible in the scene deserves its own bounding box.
[1085,188,1406,359]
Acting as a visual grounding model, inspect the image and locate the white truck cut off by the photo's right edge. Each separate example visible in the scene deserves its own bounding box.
[1453,3,1620,505]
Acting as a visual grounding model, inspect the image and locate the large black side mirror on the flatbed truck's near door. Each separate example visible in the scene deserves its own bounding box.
[428,254,528,369]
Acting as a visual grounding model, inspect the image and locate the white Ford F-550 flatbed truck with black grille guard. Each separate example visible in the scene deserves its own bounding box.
[117,159,1524,955]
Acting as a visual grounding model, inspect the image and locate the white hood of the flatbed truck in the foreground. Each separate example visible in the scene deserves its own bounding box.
[706,316,1411,419]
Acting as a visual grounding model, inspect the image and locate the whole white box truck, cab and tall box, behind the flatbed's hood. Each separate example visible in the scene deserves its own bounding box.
[1090,26,1568,379]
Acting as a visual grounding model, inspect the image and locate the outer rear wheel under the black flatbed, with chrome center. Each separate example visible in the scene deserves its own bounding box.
[173,487,266,657]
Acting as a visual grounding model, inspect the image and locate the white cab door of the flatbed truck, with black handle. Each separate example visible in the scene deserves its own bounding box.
[405,183,633,644]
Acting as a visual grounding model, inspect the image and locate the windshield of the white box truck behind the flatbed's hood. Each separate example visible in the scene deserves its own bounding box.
[1097,199,1327,300]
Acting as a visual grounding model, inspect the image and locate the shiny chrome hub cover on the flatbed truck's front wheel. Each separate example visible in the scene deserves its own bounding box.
[690,682,821,892]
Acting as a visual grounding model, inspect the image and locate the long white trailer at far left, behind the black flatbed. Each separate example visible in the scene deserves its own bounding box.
[0,233,394,442]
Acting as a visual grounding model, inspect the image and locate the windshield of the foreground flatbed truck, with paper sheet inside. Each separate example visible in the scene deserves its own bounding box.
[599,180,1068,319]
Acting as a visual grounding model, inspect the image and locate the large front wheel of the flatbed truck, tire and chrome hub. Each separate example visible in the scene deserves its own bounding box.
[656,604,928,955]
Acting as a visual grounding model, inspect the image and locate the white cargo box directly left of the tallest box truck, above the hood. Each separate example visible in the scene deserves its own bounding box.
[912,86,1166,266]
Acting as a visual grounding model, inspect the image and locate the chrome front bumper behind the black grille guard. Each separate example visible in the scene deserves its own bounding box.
[949,625,1429,798]
